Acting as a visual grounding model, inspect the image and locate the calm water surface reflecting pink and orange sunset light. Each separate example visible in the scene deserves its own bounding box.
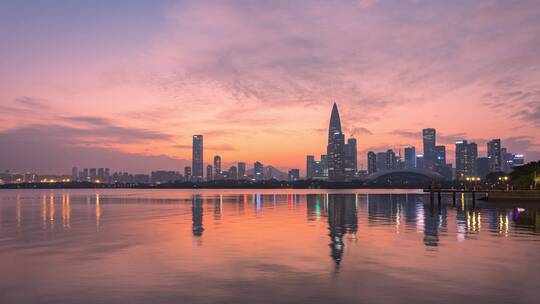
[0,190,540,303]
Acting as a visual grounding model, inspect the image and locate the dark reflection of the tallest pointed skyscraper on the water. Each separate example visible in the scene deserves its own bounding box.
[328,194,358,266]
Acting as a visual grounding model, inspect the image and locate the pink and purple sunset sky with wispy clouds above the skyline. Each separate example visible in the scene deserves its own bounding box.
[0,0,540,173]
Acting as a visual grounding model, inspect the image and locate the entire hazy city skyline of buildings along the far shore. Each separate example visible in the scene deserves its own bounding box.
[0,102,525,184]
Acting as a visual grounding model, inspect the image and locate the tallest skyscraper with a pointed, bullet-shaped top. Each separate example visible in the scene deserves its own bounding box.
[327,103,345,181]
